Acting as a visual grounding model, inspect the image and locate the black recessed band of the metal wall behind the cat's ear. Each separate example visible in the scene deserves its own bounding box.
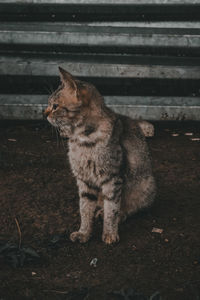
[0,75,200,97]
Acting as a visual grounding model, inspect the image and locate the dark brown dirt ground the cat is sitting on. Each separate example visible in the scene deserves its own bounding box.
[0,122,200,300]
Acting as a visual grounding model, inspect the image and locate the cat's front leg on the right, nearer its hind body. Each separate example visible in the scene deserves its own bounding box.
[102,177,122,244]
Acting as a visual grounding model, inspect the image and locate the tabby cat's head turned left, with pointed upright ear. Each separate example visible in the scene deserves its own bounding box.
[44,67,97,136]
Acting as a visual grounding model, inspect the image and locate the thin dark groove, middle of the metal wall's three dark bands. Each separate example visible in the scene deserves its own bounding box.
[0,43,200,56]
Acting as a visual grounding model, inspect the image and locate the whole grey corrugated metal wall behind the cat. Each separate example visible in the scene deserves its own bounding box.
[0,0,200,120]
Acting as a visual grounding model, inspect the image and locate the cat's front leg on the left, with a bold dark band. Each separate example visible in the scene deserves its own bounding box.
[70,180,98,243]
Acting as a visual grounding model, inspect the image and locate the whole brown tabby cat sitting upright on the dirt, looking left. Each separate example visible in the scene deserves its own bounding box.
[45,67,156,244]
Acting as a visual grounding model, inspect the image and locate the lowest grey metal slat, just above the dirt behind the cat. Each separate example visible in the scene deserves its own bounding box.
[0,95,200,120]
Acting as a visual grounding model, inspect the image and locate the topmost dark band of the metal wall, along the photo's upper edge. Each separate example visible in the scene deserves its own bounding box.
[0,0,200,22]
